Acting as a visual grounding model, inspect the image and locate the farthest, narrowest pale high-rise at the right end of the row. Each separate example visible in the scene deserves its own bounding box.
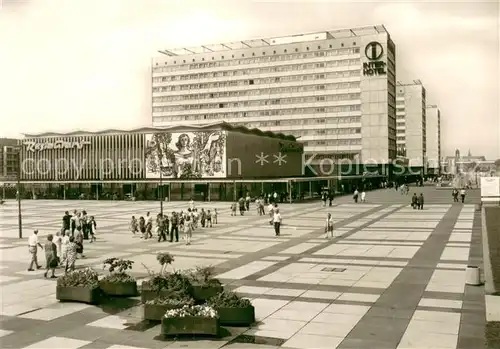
[425,105,442,175]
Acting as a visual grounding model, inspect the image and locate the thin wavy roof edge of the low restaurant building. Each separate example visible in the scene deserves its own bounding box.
[24,121,297,142]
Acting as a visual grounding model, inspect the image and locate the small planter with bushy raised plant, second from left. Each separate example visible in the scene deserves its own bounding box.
[99,258,137,297]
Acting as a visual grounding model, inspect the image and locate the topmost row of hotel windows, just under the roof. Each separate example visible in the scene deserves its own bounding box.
[153,47,360,72]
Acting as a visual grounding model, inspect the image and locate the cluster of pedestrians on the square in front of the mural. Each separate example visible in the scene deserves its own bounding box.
[130,200,218,245]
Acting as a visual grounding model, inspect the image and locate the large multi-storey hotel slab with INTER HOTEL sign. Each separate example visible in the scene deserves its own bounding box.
[152,25,396,177]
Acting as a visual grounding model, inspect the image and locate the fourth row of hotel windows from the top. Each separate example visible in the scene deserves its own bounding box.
[153,81,360,103]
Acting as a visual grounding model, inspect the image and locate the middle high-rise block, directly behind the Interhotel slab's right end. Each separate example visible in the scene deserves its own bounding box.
[396,80,427,174]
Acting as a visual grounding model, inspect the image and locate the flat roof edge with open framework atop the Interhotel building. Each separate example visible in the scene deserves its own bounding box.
[158,24,389,57]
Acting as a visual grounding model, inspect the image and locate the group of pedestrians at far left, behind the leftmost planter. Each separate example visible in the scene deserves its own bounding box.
[28,210,97,278]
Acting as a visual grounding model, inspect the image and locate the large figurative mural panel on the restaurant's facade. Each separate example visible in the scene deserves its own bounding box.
[145,131,226,179]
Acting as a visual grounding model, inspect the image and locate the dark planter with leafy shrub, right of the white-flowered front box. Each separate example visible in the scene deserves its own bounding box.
[207,291,255,326]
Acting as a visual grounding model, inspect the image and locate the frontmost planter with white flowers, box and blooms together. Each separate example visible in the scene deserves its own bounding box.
[160,305,219,336]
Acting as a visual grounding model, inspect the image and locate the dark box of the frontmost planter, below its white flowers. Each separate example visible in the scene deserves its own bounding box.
[160,316,219,336]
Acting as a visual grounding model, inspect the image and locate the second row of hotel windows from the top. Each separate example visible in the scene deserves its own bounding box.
[153,58,361,83]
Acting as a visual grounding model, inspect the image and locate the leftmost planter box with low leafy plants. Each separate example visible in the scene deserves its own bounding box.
[56,268,100,304]
